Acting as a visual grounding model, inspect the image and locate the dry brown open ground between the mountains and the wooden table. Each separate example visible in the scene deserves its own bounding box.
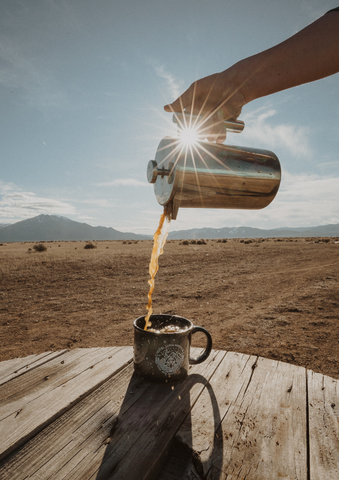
[0,239,339,378]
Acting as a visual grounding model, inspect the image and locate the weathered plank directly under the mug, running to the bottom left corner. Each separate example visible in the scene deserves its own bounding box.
[0,352,225,480]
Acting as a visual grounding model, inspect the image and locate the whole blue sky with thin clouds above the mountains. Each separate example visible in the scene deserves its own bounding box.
[0,0,339,234]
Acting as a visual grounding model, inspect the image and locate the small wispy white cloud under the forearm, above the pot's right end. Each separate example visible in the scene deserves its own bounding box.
[241,107,312,157]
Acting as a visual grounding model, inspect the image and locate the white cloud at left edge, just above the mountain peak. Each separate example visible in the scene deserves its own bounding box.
[0,183,76,223]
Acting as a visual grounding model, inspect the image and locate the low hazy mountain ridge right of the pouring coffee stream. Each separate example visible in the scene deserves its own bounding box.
[168,224,339,240]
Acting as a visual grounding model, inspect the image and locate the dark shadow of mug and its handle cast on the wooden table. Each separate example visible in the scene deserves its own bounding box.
[96,373,223,480]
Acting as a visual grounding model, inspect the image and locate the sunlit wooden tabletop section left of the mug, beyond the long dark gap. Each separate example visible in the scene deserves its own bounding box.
[0,347,132,460]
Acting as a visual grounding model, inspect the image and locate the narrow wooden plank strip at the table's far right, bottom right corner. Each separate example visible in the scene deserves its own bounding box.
[307,371,339,480]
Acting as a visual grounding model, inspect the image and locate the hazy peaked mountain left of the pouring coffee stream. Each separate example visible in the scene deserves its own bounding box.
[0,215,151,242]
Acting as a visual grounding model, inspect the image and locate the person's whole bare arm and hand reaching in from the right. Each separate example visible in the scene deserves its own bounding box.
[164,11,339,143]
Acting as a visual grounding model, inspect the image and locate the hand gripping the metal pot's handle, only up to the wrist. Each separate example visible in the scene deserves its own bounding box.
[164,65,246,143]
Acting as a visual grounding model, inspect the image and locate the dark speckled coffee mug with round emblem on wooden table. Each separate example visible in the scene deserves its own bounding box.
[133,314,212,382]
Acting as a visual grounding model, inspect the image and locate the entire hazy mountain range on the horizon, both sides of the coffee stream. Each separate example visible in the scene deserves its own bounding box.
[0,215,339,242]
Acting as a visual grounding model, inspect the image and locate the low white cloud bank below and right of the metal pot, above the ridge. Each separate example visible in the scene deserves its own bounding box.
[167,171,339,230]
